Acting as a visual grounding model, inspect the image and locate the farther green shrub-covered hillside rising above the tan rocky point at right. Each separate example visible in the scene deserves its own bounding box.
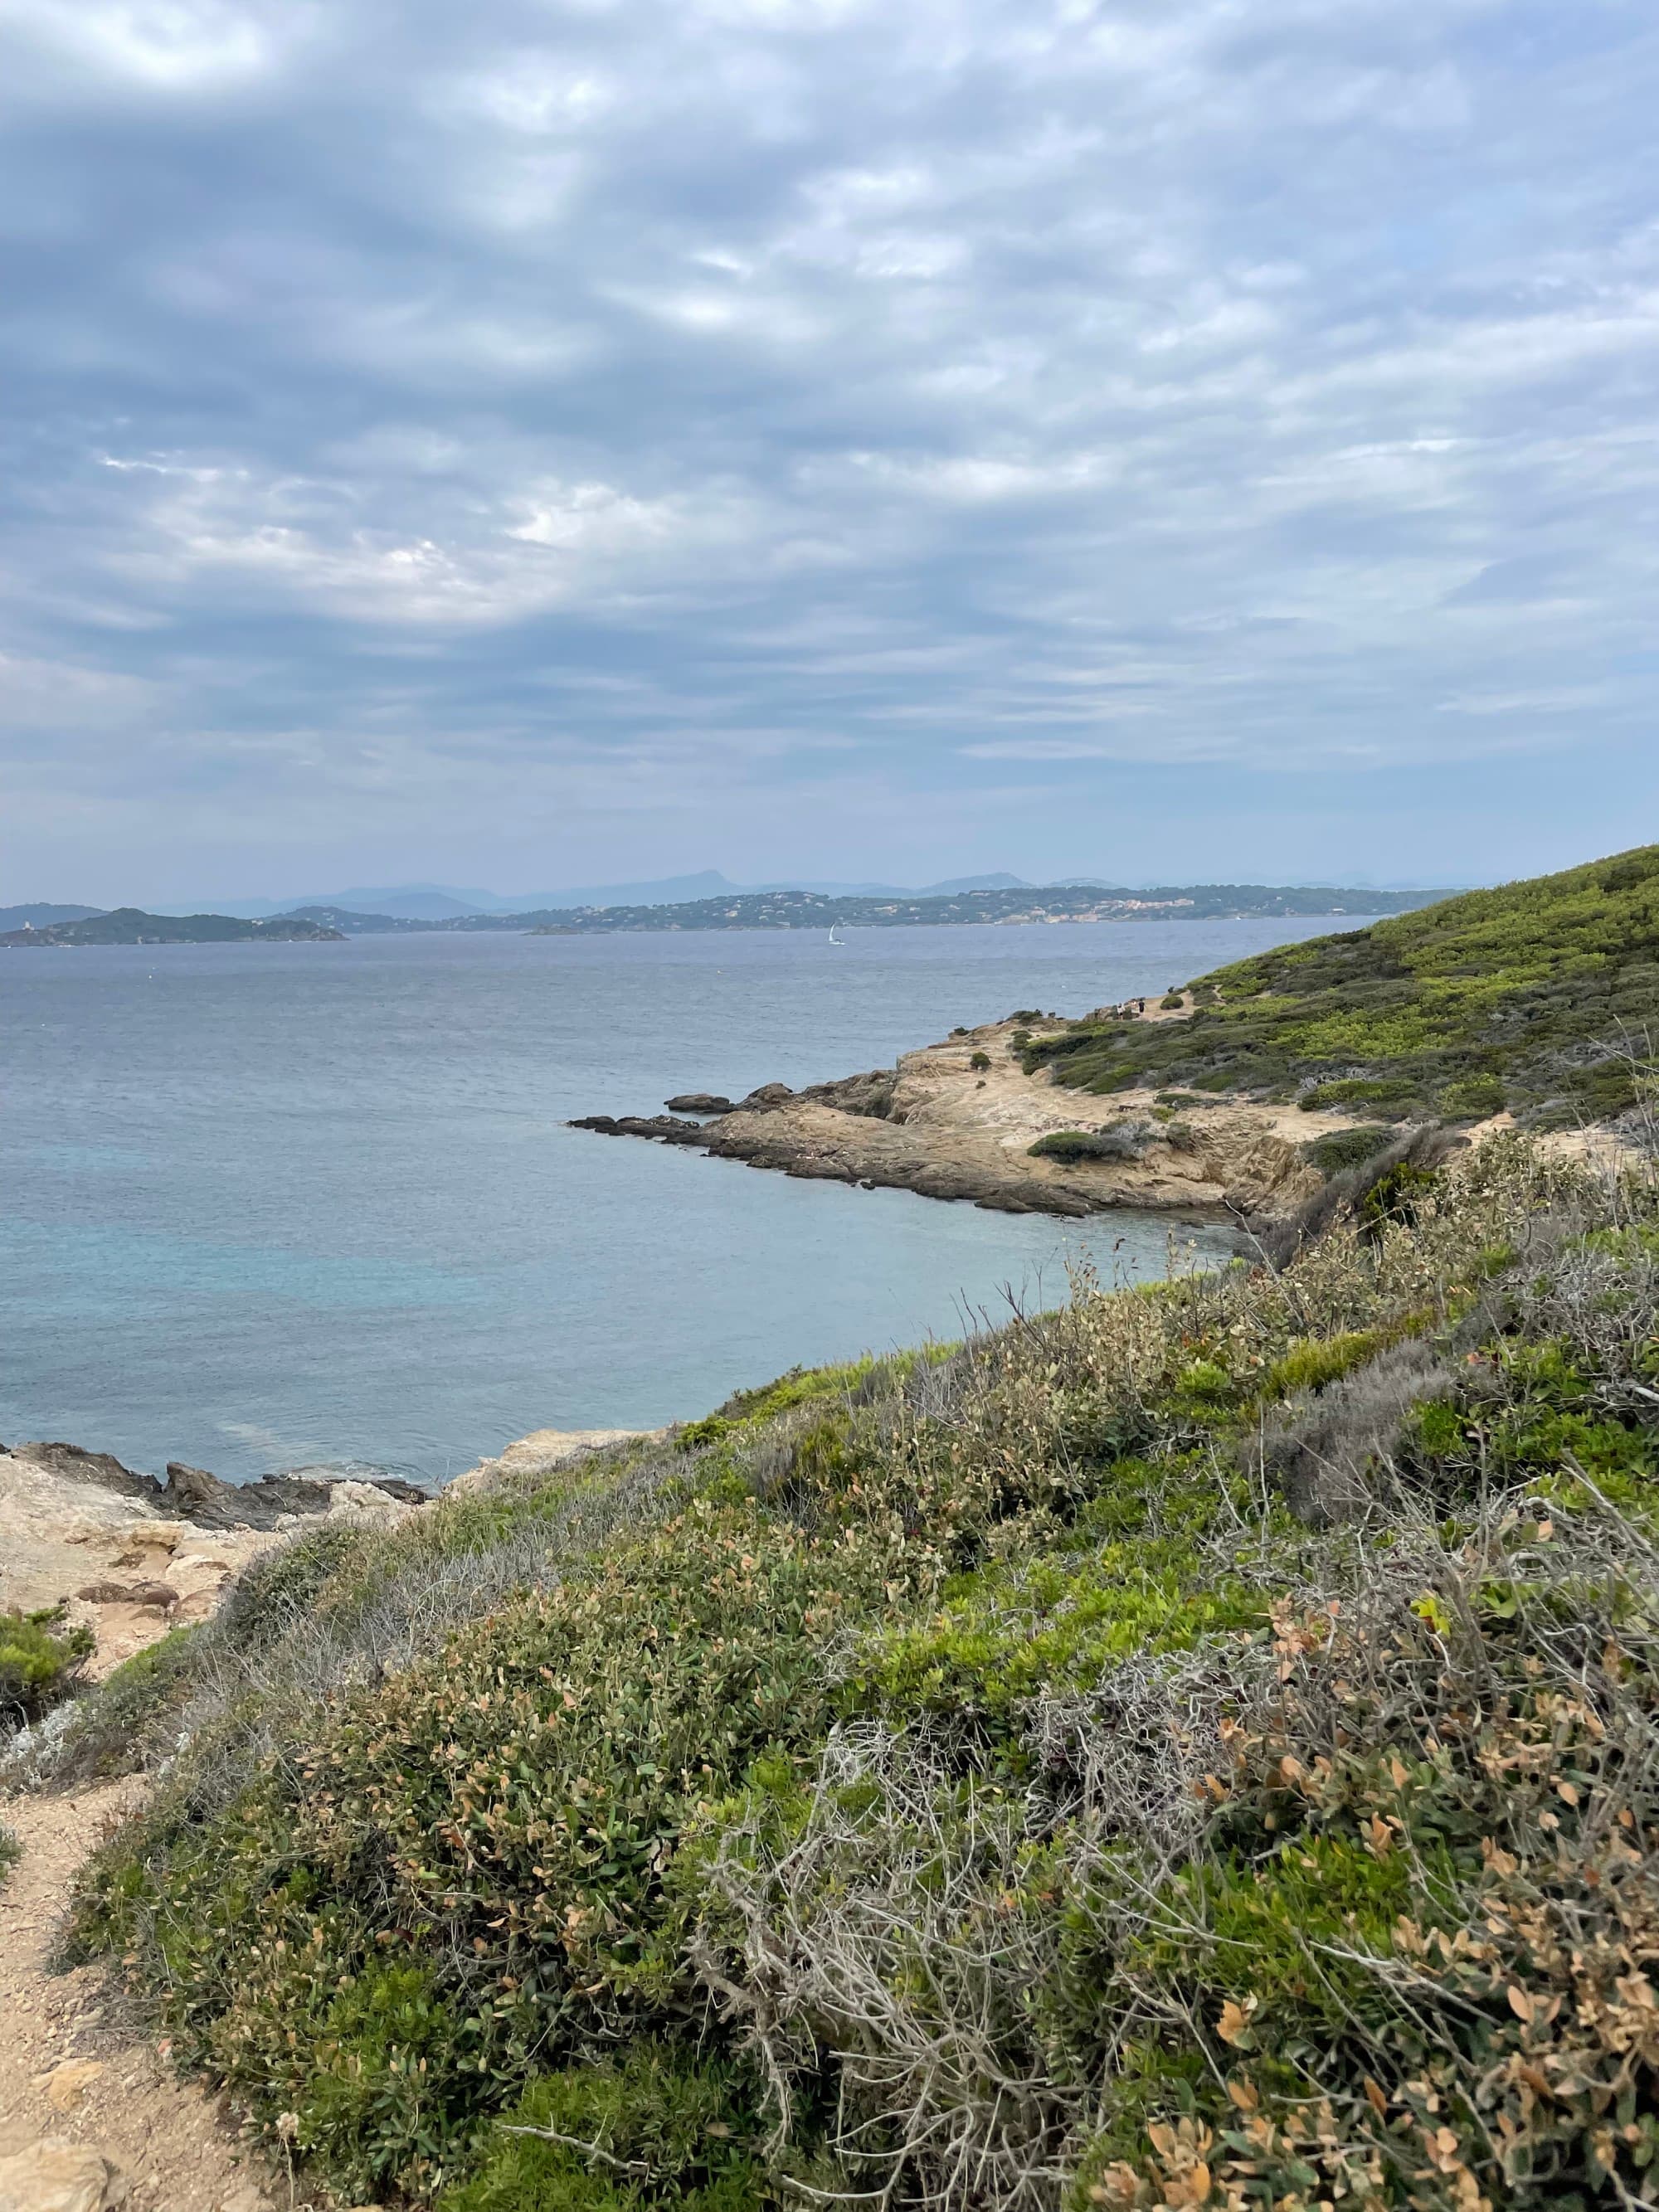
[1026,845,1659,1128]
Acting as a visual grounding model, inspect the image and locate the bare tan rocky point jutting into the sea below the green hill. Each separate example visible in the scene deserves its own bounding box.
[568,1011,1350,1221]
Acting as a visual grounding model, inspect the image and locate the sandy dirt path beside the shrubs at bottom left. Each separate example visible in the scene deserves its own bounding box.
[0,1783,289,2212]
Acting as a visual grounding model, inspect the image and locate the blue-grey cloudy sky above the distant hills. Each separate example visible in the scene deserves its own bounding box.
[0,0,1659,905]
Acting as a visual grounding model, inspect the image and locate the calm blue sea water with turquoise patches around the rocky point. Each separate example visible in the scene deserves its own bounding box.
[0,922,1362,1480]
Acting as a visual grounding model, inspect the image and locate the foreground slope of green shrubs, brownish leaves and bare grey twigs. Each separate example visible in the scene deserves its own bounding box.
[22,1137,1659,2212]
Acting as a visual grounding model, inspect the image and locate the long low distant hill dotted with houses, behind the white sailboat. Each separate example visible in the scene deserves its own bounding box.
[513,882,1431,936]
